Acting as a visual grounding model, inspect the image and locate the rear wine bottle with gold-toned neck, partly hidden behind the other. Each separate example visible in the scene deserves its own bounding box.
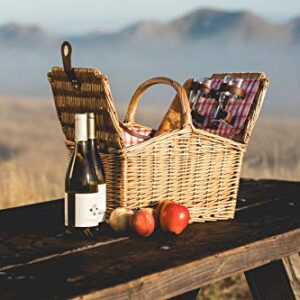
[88,113,106,223]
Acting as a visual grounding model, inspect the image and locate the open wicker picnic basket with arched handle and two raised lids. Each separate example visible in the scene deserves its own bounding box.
[48,67,268,222]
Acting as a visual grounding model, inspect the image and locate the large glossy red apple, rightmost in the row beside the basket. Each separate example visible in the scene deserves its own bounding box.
[159,201,190,234]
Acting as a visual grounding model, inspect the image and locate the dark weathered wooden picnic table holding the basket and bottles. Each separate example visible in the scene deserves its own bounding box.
[0,180,300,300]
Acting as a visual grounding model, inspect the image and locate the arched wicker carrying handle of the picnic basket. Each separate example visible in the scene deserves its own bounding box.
[124,77,192,128]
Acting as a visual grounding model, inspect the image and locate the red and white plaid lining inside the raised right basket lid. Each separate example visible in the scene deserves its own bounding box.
[194,79,260,138]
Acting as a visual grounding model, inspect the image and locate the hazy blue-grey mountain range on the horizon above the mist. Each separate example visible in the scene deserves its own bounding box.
[0,9,300,47]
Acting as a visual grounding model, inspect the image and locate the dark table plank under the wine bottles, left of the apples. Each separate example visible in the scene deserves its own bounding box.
[0,200,128,270]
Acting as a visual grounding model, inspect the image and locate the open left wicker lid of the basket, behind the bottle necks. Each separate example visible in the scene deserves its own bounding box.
[48,67,124,150]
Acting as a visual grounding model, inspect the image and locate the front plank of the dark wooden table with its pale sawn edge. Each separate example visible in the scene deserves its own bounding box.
[0,185,300,299]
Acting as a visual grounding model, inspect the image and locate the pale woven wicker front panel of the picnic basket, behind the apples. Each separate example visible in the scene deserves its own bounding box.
[125,131,244,222]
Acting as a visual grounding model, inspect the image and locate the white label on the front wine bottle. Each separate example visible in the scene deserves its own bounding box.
[65,193,100,227]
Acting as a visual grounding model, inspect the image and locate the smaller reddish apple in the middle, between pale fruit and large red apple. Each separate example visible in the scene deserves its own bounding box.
[130,208,155,237]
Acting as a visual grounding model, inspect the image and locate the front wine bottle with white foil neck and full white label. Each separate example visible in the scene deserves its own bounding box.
[65,114,100,235]
